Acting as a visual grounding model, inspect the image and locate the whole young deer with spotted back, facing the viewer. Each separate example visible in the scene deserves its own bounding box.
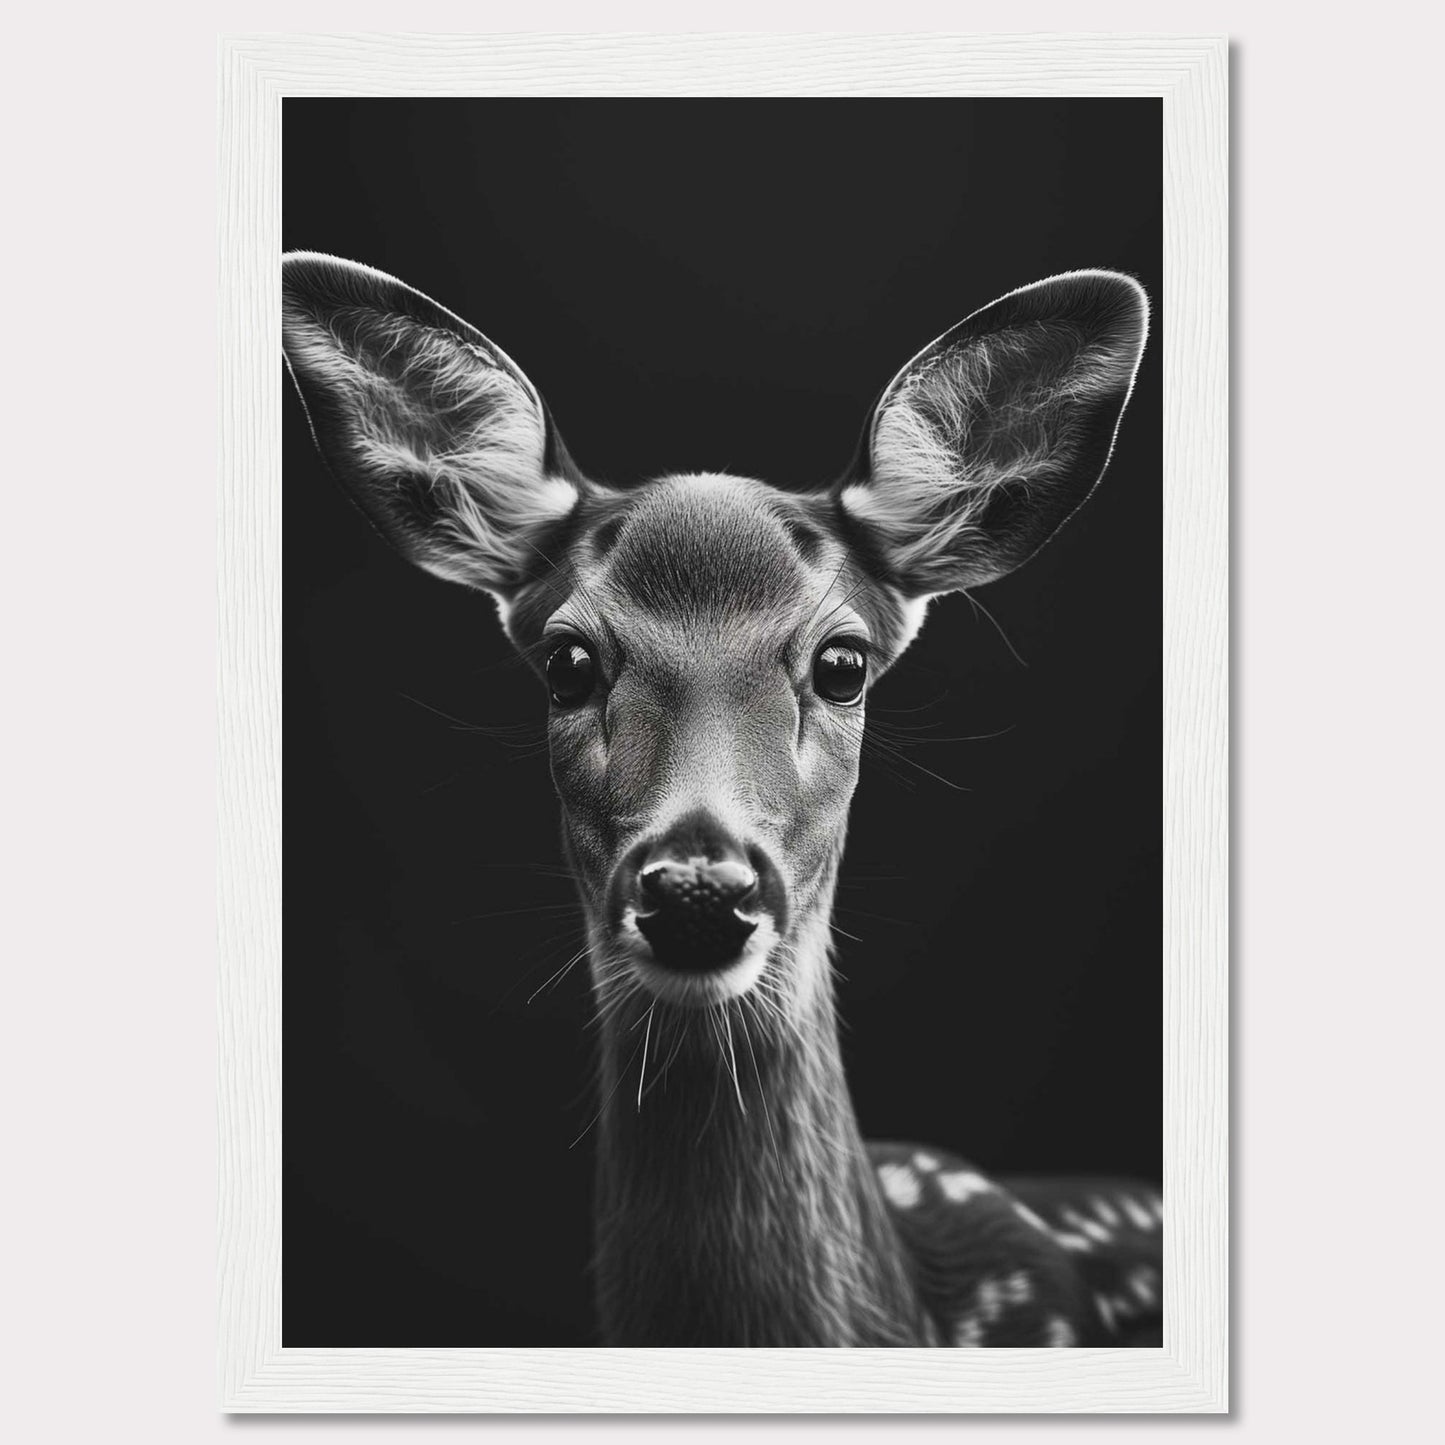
[283,253,1162,1345]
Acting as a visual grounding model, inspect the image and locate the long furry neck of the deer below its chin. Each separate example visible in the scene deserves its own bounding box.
[597,890,928,1345]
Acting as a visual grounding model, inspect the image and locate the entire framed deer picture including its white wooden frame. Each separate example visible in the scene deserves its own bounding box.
[221,35,1228,1413]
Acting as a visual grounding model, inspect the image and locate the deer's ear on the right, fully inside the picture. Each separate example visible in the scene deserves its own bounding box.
[841,270,1149,597]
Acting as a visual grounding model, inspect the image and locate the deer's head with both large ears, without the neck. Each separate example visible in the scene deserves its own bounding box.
[283,254,1147,1033]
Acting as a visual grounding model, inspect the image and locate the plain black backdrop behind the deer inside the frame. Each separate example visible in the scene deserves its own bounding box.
[283,100,1168,1345]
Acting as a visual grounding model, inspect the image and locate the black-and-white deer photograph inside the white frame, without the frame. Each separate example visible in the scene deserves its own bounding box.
[275,97,1172,1350]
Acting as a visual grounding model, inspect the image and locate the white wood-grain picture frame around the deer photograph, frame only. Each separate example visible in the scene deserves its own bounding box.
[220,35,1228,1413]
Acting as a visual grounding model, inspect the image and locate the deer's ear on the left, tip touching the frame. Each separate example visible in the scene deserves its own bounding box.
[282,251,578,598]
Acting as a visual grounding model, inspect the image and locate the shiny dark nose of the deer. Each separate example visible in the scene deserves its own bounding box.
[637,855,759,972]
